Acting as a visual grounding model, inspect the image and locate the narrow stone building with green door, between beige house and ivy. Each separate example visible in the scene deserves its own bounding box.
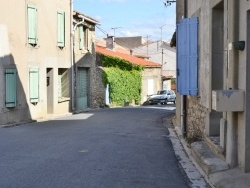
[73,11,99,111]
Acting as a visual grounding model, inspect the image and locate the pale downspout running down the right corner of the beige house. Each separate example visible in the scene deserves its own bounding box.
[70,0,75,112]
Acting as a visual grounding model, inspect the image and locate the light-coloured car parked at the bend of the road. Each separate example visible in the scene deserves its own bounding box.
[148,90,176,104]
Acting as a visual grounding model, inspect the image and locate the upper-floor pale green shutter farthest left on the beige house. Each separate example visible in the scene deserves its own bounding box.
[28,5,37,44]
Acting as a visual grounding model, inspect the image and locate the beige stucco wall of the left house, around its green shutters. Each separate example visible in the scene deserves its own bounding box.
[0,0,70,124]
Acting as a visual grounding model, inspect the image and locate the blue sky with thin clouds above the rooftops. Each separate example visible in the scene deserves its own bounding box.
[74,0,176,42]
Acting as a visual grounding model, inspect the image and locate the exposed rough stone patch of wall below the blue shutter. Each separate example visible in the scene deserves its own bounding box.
[186,96,208,141]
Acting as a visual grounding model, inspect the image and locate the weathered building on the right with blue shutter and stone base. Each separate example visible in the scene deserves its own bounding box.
[177,0,250,172]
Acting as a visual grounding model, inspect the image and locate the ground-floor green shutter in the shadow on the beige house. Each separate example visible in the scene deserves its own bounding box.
[5,69,17,107]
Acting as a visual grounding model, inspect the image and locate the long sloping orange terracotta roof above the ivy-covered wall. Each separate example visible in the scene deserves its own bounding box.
[96,45,161,67]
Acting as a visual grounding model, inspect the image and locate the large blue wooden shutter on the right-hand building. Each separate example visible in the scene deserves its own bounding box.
[177,18,198,96]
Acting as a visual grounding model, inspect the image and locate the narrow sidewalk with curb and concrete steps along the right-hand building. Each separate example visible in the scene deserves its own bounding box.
[169,119,250,188]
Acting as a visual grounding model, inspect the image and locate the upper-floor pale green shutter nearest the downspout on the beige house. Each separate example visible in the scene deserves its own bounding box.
[57,12,65,47]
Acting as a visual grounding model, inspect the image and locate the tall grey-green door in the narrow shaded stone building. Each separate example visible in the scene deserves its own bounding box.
[76,68,88,110]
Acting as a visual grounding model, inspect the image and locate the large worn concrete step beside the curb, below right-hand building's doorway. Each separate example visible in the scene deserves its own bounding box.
[191,141,229,175]
